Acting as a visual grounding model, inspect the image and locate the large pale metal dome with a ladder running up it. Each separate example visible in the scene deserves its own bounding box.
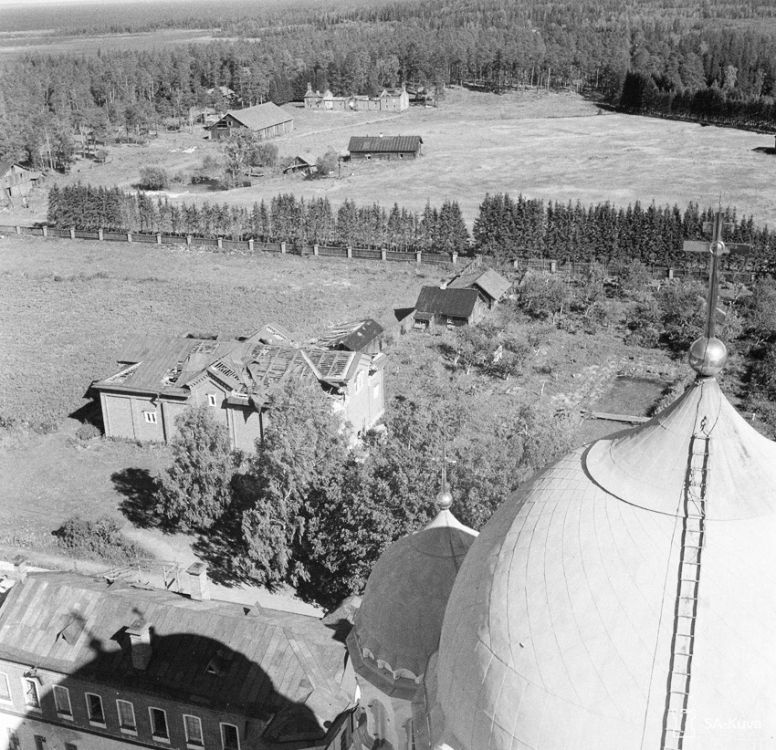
[432,378,776,750]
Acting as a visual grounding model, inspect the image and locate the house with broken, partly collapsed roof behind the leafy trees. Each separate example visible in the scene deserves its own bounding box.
[91,326,385,451]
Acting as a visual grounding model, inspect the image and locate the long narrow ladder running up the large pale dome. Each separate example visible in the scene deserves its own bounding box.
[660,428,709,750]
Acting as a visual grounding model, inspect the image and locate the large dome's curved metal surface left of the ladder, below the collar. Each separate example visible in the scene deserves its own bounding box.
[438,450,676,750]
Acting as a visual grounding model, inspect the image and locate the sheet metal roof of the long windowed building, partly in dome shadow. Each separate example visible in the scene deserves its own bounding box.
[0,573,349,734]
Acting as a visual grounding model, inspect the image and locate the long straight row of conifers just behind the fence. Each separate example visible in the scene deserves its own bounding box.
[48,184,776,273]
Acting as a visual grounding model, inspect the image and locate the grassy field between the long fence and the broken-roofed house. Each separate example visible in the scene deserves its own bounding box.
[0,237,430,422]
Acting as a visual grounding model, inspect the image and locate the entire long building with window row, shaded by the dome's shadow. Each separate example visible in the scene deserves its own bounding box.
[0,563,358,750]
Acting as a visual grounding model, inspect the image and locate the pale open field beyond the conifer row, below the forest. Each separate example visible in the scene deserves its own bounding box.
[6,89,776,231]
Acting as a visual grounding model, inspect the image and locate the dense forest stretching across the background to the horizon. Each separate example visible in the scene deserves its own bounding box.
[0,0,776,164]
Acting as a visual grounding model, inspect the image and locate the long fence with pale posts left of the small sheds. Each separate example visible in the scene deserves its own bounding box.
[0,224,459,265]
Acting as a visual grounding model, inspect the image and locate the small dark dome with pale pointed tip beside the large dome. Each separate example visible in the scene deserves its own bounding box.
[348,509,477,683]
